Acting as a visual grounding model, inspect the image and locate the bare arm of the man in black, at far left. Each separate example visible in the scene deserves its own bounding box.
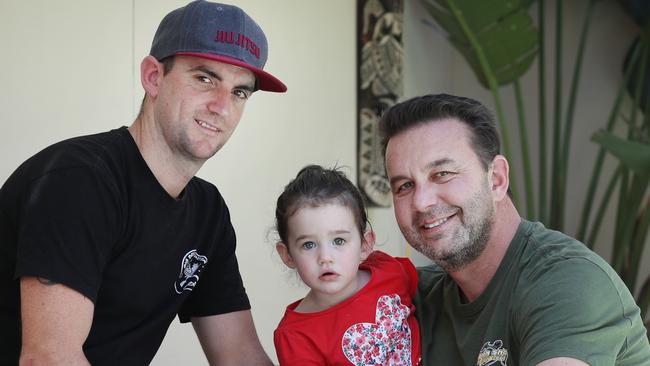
[20,277,95,366]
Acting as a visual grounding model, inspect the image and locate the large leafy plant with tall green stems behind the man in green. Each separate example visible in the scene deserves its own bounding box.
[421,0,650,325]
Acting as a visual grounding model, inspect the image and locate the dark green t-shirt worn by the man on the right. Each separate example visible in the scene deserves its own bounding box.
[415,220,650,366]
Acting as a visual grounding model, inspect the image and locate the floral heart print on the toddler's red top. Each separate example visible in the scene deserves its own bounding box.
[341,294,411,366]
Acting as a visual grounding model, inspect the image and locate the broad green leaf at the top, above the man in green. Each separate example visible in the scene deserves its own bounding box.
[422,0,539,88]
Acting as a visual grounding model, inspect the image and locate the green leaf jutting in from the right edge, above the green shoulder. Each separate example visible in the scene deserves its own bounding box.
[591,130,650,175]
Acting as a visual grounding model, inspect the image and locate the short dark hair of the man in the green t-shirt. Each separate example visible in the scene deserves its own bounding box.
[379,94,501,170]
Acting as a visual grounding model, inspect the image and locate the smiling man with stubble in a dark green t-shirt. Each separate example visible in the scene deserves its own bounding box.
[380,94,650,366]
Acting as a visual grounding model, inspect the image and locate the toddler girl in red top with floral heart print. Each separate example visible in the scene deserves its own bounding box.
[274,165,420,366]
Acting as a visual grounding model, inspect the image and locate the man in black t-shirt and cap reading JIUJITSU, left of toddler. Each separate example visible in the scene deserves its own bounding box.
[0,1,286,365]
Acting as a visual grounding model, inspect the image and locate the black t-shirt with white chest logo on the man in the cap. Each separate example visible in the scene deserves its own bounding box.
[0,127,250,365]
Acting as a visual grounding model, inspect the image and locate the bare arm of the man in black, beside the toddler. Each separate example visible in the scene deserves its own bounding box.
[192,310,273,366]
